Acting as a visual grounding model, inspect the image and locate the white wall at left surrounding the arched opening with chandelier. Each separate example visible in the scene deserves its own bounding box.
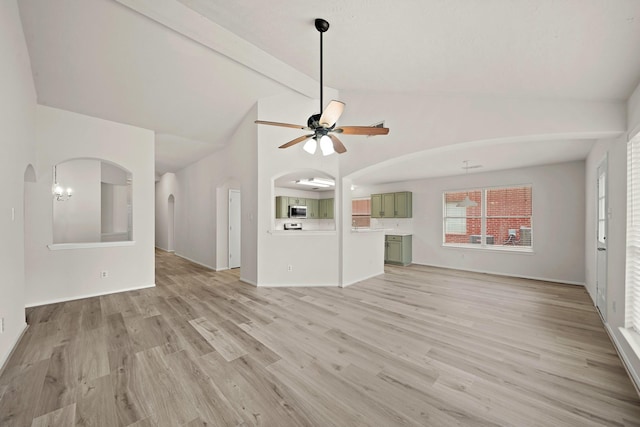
[25,105,155,306]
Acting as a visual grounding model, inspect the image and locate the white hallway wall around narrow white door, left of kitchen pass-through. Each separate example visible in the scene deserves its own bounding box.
[174,103,258,283]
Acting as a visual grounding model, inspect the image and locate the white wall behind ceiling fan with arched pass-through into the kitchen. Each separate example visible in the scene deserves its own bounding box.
[255,94,341,286]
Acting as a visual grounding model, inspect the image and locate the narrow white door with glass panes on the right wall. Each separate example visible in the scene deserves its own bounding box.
[596,157,609,320]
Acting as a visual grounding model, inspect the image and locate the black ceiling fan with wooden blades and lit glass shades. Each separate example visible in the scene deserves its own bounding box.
[255,18,389,156]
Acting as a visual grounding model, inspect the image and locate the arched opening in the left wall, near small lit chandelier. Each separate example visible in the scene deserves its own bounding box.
[52,159,133,244]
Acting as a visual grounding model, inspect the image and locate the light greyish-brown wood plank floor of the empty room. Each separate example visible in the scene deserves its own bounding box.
[0,251,640,427]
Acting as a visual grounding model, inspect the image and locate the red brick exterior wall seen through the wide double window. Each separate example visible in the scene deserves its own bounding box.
[445,187,532,246]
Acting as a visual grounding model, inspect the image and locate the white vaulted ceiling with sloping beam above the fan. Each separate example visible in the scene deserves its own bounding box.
[19,0,640,181]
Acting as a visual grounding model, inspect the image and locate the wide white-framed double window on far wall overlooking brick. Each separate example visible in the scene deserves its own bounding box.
[443,185,532,250]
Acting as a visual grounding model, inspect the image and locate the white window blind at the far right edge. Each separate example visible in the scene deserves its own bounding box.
[625,135,640,333]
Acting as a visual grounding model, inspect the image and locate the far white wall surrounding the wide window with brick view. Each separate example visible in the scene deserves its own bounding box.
[356,161,585,284]
